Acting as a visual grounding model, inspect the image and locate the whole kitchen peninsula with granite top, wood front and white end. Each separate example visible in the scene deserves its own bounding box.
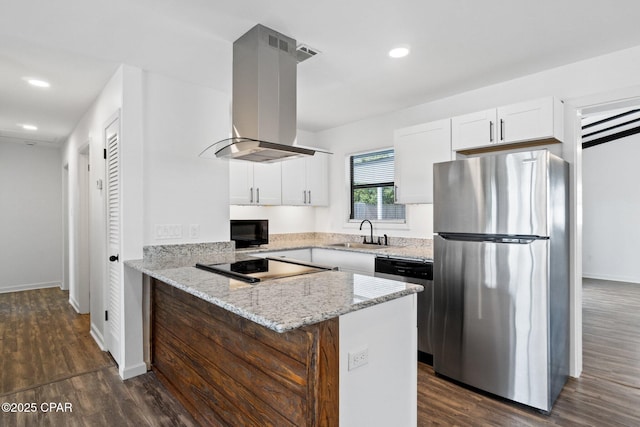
[126,244,422,426]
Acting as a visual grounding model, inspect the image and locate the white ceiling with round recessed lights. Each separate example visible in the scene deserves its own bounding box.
[0,0,640,148]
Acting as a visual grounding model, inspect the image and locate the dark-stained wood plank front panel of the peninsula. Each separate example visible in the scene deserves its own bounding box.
[151,279,339,426]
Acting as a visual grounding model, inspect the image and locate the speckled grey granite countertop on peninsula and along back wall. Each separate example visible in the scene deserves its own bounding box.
[125,239,428,332]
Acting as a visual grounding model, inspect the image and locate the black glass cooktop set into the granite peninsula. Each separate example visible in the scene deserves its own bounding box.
[196,257,332,283]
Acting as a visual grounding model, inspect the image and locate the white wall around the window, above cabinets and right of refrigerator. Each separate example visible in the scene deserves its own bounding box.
[316,46,640,376]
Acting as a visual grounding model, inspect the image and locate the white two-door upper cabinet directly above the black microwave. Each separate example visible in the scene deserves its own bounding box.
[229,160,282,206]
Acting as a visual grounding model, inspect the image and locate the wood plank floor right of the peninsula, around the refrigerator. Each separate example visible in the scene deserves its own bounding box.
[418,279,640,427]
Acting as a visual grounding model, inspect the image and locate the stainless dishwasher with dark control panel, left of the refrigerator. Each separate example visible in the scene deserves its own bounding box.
[375,256,433,365]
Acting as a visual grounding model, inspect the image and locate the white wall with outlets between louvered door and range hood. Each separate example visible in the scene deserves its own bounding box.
[118,67,230,379]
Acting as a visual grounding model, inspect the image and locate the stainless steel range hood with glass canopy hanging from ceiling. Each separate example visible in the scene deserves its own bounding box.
[200,24,330,163]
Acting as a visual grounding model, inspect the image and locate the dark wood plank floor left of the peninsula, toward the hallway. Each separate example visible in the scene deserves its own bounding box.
[0,288,197,427]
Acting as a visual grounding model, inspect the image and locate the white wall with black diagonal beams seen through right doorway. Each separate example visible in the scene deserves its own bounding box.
[581,99,640,283]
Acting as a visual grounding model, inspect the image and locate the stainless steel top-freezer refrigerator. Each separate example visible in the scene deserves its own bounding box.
[433,150,569,412]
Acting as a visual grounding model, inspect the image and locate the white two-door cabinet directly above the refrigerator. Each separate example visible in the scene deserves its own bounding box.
[451,97,563,151]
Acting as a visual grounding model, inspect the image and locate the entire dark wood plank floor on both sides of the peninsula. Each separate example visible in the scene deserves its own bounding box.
[0,280,640,427]
